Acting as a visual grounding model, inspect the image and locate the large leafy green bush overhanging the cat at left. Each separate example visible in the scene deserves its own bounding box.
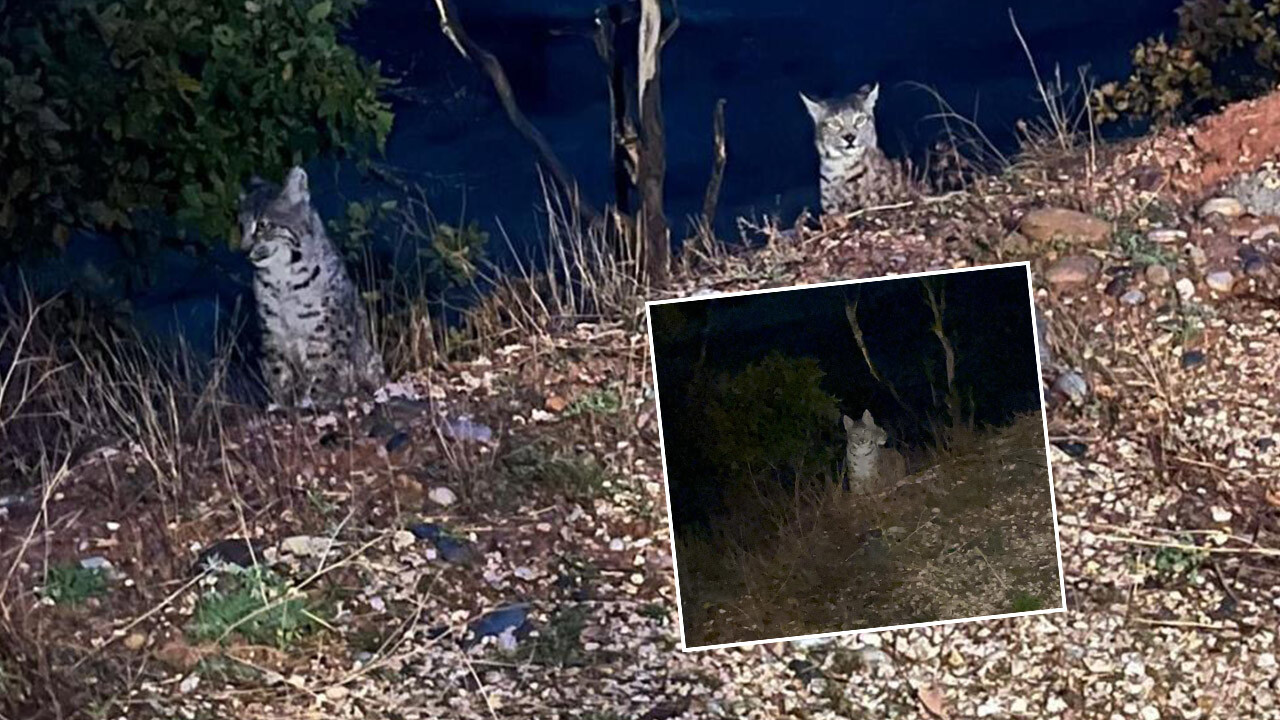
[0,0,392,258]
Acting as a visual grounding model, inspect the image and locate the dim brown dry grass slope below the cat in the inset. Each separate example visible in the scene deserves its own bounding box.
[676,413,1056,647]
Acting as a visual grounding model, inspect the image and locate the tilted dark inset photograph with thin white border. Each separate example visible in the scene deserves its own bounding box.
[648,263,1065,650]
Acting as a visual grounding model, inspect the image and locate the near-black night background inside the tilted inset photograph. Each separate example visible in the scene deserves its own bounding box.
[652,265,1041,527]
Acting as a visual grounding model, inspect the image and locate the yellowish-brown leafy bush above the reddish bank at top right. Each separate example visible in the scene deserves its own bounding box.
[1093,0,1280,123]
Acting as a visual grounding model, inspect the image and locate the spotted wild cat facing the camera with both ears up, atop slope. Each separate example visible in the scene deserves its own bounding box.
[800,85,906,214]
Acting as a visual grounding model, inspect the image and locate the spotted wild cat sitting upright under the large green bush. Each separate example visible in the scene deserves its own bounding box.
[239,168,387,406]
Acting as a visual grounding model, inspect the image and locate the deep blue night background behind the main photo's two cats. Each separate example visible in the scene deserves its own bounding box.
[0,0,1178,350]
